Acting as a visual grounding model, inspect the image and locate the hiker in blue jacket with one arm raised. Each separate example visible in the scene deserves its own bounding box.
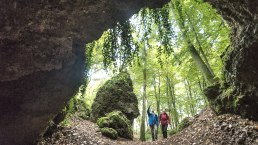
[147,106,159,141]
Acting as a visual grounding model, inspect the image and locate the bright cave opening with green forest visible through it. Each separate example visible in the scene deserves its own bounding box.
[40,1,231,143]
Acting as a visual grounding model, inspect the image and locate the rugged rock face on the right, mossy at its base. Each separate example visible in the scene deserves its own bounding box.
[206,0,258,121]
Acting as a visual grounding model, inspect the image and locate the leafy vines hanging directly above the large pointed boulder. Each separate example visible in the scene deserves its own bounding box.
[102,21,139,72]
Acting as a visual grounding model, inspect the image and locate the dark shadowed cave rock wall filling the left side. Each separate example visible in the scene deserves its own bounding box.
[0,0,167,145]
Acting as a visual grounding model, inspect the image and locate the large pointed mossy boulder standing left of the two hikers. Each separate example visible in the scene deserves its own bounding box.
[91,72,139,123]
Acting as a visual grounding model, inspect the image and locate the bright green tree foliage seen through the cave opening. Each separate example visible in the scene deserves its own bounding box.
[84,0,232,137]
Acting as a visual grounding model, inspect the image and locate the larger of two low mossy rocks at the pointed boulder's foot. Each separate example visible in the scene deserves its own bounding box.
[97,111,133,139]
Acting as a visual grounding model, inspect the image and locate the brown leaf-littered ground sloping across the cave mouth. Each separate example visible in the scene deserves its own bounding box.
[38,108,258,145]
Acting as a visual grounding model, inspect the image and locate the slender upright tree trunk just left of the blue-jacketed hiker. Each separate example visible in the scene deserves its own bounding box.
[140,46,147,141]
